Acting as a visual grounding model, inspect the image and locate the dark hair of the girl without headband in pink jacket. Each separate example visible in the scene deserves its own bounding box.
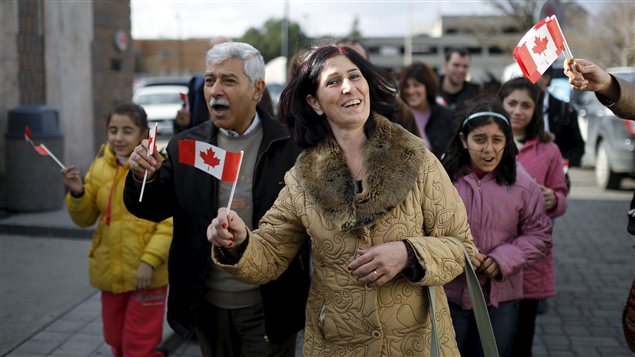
[498,77,552,142]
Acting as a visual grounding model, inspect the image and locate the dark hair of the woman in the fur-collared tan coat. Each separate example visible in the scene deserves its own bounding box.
[280,45,396,148]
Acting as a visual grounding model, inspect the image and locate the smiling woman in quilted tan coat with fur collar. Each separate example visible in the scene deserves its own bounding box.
[208,45,476,356]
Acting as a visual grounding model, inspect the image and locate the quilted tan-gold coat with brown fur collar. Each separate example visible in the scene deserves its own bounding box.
[213,116,476,357]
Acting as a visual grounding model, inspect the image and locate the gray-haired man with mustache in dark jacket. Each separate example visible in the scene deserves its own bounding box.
[124,42,309,357]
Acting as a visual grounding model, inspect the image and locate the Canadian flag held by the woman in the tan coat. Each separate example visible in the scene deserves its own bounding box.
[179,140,242,182]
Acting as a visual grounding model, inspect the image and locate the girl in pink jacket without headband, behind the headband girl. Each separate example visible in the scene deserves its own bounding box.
[498,77,567,357]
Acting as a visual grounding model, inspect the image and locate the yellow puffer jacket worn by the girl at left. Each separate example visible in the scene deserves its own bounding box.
[66,145,172,293]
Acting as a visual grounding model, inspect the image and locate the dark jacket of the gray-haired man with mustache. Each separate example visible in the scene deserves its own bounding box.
[124,110,310,343]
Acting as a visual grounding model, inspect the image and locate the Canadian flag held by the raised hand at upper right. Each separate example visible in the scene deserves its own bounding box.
[514,15,565,83]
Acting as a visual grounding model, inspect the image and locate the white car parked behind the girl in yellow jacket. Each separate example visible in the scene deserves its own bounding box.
[132,85,188,136]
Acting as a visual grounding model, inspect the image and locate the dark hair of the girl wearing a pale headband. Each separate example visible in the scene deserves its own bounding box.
[441,97,518,185]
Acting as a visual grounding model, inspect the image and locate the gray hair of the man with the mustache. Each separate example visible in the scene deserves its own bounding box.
[207,42,265,84]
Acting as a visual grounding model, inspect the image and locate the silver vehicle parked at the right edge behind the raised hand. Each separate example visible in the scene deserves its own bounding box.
[572,67,635,189]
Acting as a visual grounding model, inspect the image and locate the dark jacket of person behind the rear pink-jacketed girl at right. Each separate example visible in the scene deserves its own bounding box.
[540,93,584,167]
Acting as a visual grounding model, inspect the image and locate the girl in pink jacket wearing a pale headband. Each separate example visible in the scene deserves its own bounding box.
[442,101,551,356]
